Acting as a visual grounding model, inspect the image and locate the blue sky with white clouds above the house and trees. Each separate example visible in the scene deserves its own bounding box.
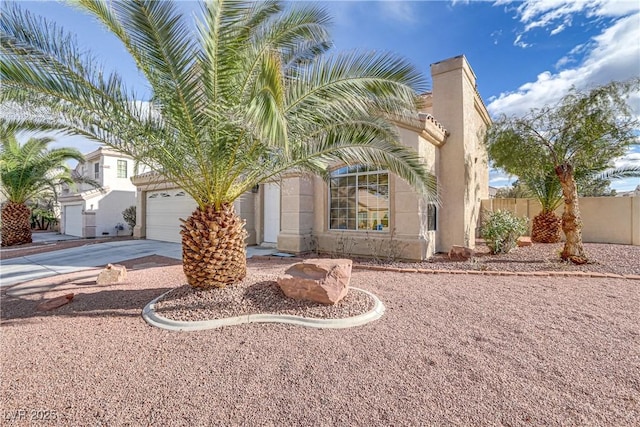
[6,0,640,191]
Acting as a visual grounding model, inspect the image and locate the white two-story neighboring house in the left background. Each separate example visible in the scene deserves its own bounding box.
[58,147,136,237]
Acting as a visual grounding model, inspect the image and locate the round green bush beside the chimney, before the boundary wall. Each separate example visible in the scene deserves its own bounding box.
[481,210,529,254]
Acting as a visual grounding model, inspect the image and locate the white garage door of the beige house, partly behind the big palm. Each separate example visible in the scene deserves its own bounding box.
[146,189,198,243]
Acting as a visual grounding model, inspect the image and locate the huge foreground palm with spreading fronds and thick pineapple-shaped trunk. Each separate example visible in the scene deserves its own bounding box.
[0,0,436,288]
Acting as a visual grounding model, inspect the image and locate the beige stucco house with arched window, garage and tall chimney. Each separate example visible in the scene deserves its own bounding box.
[132,56,491,260]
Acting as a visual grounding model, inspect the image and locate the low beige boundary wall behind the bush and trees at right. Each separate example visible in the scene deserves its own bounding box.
[482,197,640,245]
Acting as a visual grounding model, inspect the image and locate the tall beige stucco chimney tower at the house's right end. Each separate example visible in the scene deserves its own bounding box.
[431,56,490,252]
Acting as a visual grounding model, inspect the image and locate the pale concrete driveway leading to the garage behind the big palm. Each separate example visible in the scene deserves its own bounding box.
[0,240,275,286]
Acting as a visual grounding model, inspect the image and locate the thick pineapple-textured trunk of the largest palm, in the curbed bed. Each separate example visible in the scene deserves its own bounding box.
[180,204,247,289]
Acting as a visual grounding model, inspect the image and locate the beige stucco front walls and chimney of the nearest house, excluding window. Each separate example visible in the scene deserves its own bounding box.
[278,56,490,260]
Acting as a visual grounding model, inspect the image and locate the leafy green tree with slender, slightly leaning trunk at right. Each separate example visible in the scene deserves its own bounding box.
[485,78,640,264]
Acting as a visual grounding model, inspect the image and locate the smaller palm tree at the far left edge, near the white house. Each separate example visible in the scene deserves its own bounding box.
[0,133,84,246]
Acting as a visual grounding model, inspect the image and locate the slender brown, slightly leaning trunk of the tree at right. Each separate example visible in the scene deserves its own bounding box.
[556,164,588,264]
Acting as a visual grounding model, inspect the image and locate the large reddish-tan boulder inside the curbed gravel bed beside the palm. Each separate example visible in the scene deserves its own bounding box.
[278,259,353,304]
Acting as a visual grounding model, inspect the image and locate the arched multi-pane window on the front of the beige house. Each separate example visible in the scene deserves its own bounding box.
[329,165,389,231]
